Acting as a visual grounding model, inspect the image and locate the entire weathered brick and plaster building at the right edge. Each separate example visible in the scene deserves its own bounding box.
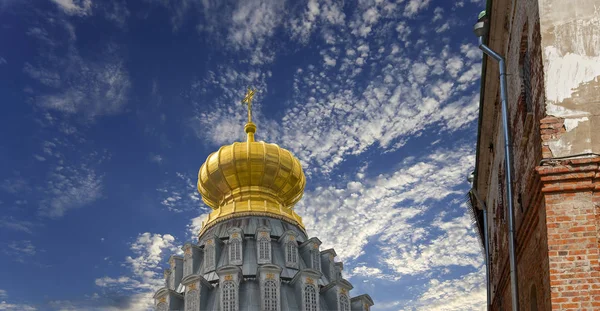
[473,0,600,310]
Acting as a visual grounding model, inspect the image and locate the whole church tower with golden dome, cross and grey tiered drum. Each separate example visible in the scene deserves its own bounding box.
[154,90,373,311]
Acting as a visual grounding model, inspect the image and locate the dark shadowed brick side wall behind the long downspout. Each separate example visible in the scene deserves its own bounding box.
[480,0,551,310]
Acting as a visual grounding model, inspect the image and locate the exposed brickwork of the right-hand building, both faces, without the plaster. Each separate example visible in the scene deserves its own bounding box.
[482,0,600,310]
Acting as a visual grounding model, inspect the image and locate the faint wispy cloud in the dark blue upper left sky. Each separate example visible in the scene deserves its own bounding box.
[23,18,131,119]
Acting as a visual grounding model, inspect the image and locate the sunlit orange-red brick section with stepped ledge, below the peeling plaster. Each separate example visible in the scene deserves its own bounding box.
[538,158,600,310]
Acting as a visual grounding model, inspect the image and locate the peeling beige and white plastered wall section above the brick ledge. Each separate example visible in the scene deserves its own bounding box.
[539,0,600,158]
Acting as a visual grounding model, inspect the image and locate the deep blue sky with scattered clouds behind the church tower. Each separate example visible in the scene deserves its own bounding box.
[0,0,485,310]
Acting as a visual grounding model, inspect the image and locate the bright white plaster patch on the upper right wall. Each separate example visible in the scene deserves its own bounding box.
[544,46,600,103]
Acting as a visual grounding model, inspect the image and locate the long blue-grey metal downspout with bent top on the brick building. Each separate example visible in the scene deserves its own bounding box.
[479,37,519,311]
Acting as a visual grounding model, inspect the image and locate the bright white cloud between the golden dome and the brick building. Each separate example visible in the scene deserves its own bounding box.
[296,146,477,264]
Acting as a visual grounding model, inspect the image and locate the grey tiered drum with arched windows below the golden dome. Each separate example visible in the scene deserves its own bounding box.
[154,216,373,311]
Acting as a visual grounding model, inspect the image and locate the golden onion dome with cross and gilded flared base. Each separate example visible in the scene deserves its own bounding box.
[198,90,306,233]
